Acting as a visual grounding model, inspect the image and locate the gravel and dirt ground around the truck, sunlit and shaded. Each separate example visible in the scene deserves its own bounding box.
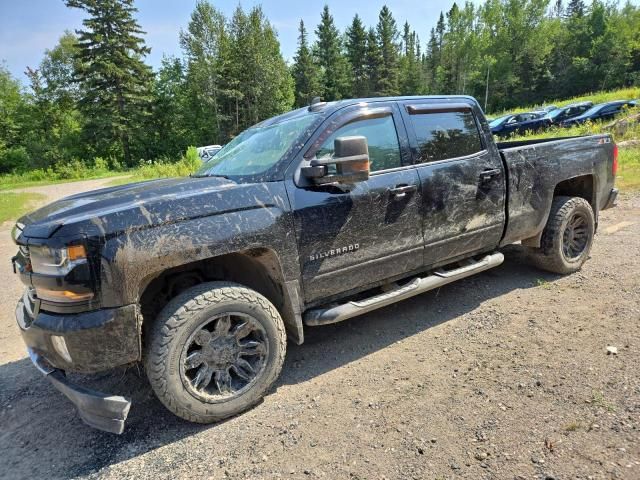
[0,184,640,480]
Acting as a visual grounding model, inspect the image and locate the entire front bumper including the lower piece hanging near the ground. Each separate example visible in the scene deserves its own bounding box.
[16,290,141,433]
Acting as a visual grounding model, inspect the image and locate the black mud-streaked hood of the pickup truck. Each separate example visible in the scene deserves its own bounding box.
[18,177,273,238]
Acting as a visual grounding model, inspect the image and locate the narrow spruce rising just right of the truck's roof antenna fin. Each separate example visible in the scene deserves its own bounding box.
[314,5,349,100]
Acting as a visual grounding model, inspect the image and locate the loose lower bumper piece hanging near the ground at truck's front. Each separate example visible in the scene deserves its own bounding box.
[27,348,131,434]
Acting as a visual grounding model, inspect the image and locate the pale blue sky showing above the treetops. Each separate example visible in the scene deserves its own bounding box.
[0,0,478,84]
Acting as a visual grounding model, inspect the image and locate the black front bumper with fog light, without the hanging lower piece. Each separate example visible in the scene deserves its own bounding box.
[16,289,141,373]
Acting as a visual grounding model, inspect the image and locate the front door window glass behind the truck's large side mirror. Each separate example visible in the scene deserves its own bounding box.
[316,115,402,172]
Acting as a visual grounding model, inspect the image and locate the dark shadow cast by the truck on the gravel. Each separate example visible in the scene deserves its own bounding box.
[0,247,558,478]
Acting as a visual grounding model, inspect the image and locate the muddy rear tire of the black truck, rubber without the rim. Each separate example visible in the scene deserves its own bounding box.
[531,196,595,274]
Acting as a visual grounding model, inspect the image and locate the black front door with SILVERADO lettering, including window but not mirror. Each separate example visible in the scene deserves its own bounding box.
[288,102,423,302]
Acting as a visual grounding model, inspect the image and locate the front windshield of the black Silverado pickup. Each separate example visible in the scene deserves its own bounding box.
[194,115,316,177]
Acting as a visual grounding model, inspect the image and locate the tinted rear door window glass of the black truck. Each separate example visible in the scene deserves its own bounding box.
[411,111,483,163]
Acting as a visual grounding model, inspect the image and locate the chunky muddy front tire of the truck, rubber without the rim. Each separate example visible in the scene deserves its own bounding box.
[144,282,286,423]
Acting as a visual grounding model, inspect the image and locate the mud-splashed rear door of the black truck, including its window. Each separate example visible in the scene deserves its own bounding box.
[401,99,506,265]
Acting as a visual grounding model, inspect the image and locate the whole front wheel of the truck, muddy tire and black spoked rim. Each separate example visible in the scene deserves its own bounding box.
[145,282,286,423]
